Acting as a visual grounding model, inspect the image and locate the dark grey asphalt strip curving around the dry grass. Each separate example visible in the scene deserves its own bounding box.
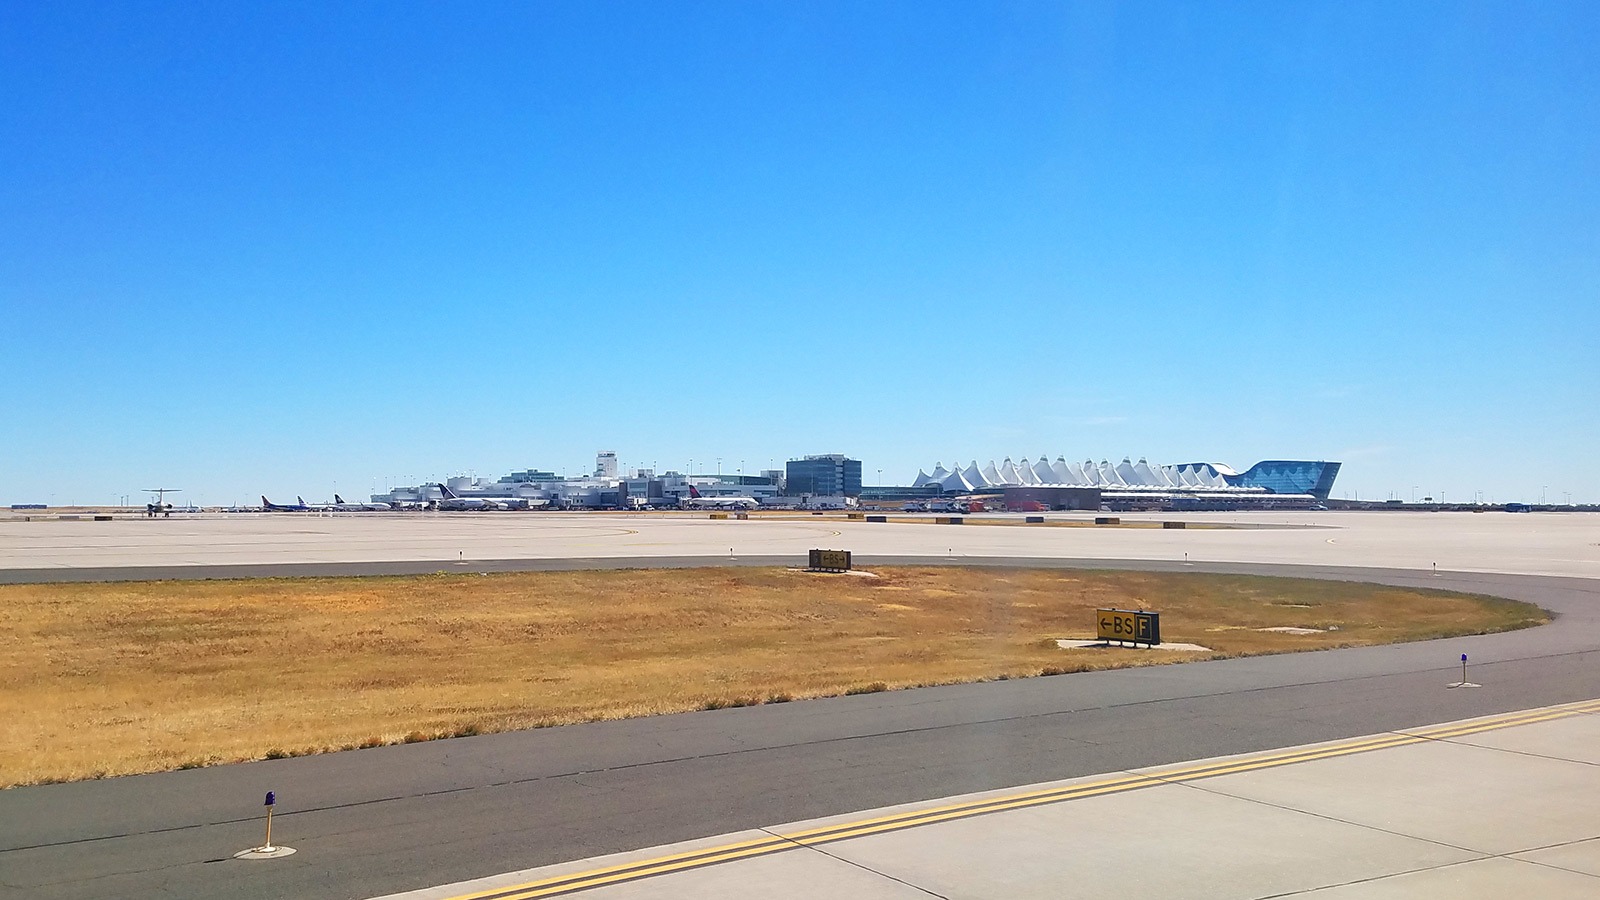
[0,557,1600,898]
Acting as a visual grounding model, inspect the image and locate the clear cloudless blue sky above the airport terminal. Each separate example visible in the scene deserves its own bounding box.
[0,0,1600,504]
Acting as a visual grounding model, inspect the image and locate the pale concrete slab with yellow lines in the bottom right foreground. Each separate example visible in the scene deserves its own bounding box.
[384,700,1600,900]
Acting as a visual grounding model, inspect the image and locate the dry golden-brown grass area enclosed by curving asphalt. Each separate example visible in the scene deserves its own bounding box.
[0,567,1546,786]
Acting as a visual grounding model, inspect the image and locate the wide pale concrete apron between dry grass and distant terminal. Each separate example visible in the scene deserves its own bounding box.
[0,511,1600,578]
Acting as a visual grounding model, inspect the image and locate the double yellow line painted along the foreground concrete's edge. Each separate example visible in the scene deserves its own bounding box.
[451,700,1600,900]
